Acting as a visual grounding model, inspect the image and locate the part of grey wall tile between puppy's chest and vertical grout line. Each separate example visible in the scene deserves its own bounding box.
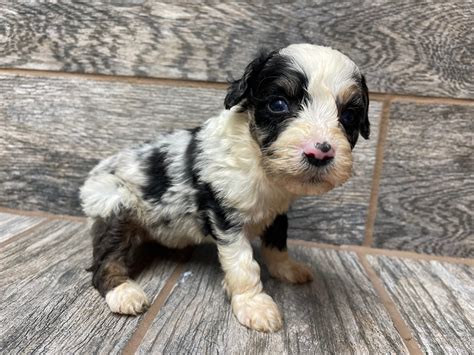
[288,102,382,245]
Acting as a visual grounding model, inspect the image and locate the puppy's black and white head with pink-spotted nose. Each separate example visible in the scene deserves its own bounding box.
[225,44,369,195]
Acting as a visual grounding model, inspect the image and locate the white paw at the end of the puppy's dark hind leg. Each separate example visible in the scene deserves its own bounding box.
[105,280,150,315]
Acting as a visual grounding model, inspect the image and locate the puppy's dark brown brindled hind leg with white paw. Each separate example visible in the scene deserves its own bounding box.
[90,212,149,315]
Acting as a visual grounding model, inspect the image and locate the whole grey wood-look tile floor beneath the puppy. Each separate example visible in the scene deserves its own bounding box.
[0,212,474,354]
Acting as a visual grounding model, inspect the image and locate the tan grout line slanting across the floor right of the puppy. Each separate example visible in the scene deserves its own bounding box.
[357,252,423,355]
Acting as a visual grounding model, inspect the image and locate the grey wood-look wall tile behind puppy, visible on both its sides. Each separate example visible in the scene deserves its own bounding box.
[0,75,381,248]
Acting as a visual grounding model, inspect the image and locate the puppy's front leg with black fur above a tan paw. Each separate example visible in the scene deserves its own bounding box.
[262,215,313,283]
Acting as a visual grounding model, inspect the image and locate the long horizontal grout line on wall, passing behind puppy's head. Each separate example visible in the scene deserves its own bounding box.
[0,68,474,106]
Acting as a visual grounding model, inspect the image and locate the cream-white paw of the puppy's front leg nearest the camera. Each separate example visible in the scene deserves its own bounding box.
[232,292,283,332]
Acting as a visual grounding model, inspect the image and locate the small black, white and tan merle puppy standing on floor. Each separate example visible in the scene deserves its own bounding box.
[81,44,369,332]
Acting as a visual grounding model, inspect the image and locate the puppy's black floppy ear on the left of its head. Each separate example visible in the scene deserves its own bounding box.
[224,51,276,111]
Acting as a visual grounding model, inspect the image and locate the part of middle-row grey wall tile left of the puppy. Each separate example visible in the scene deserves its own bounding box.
[0,76,224,215]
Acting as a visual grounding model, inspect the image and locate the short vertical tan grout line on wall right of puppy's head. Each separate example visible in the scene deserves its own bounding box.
[362,96,392,246]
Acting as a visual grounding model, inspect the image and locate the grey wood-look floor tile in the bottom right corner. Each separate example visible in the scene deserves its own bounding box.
[367,256,474,354]
